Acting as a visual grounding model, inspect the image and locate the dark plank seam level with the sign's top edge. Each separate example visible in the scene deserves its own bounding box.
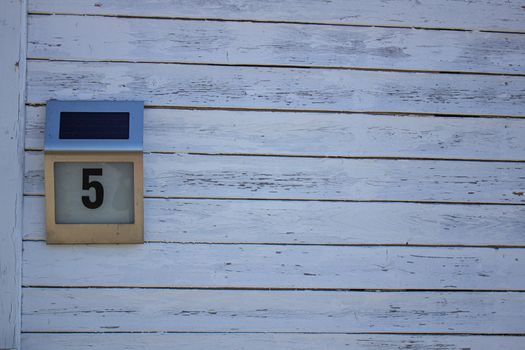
[26,102,525,119]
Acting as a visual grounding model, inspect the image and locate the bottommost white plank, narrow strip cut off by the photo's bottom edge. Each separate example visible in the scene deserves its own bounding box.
[22,333,525,350]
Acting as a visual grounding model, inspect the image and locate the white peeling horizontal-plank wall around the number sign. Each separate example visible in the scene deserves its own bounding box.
[18,0,525,350]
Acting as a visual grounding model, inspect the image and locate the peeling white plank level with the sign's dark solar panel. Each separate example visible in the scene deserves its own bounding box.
[25,107,525,160]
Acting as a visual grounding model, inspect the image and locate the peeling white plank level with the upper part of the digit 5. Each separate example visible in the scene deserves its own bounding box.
[25,152,525,203]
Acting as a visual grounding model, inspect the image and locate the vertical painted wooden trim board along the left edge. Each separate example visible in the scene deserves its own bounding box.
[0,0,27,349]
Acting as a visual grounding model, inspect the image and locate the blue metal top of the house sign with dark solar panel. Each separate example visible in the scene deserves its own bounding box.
[44,100,144,152]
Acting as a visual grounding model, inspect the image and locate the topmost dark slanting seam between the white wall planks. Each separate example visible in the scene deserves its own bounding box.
[28,11,525,35]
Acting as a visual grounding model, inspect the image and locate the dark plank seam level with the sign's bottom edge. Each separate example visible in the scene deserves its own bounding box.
[22,238,525,250]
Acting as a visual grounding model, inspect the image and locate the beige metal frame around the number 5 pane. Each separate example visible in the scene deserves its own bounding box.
[44,152,144,244]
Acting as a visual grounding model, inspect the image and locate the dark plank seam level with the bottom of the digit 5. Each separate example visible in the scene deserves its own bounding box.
[24,192,525,206]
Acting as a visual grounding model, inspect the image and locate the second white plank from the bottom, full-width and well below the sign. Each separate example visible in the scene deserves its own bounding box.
[22,288,525,334]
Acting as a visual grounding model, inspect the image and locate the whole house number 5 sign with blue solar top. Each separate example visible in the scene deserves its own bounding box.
[44,100,144,243]
